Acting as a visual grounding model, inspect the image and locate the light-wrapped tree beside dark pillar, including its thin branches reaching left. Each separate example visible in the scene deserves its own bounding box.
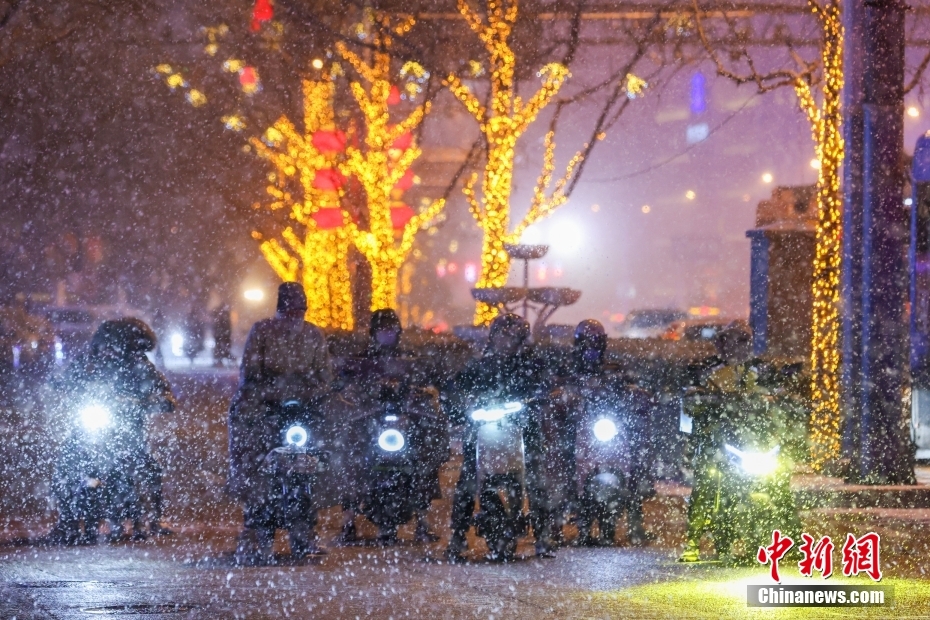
[695,0,843,469]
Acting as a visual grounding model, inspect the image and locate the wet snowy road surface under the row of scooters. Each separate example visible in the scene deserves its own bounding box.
[0,372,930,620]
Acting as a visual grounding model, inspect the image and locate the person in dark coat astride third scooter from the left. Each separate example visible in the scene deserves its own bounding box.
[338,309,449,543]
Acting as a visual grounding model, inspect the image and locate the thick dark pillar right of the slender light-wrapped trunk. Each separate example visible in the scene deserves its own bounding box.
[852,0,914,484]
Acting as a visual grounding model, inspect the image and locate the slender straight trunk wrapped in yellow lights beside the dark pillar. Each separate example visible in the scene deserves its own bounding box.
[795,2,843,469]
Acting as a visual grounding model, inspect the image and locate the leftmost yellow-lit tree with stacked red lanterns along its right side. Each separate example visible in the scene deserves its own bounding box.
[250,80,353,329]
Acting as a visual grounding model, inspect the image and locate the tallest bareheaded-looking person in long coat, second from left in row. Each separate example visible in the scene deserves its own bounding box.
[227,282,332,562]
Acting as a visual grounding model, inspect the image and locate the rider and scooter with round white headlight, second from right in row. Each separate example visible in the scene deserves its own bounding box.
[549,320,655,546]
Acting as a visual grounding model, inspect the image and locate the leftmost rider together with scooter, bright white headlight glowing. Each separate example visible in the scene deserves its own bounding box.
[50,318,175,544]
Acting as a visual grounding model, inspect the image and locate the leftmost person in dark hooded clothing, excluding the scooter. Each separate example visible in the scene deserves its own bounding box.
[51,318,175,543]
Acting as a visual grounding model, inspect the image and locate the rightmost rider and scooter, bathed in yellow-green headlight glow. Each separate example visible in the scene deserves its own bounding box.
[679,325,806,562]
